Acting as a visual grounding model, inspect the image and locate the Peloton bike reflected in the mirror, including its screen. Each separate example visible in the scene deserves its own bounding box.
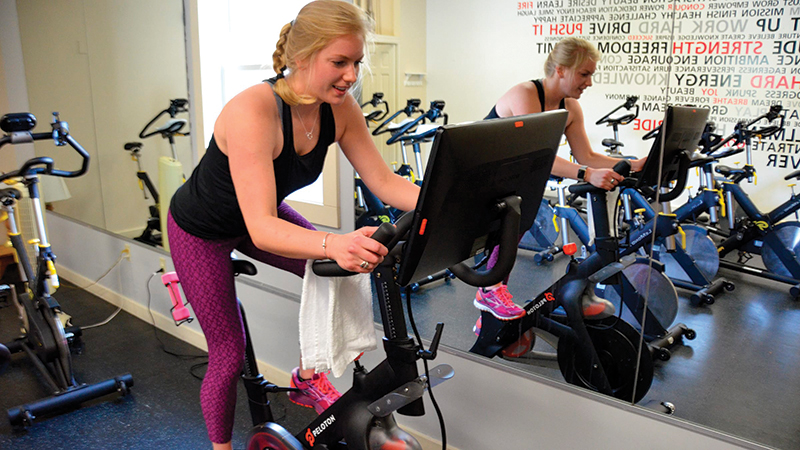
[470,107,705,403]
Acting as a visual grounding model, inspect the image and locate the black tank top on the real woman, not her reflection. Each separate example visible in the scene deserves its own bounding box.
[169,78,336,239]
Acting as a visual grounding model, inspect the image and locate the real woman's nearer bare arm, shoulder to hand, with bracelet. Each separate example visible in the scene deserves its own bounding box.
[219,85,387,272]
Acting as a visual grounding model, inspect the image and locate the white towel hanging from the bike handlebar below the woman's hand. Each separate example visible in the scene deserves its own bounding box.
[300,260,378,378]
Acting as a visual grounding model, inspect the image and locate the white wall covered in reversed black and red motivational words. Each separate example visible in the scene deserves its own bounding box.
[513,0,800,202]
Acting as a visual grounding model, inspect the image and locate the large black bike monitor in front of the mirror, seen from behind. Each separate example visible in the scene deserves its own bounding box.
[398,110,568,286]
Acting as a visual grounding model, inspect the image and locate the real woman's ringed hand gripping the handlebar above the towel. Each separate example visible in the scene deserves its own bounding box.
[327,227,389,273]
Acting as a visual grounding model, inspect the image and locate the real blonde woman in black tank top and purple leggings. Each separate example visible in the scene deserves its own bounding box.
[168,0,419,449]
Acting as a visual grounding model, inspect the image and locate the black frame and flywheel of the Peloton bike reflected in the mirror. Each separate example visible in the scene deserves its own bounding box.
[470,160,660,402]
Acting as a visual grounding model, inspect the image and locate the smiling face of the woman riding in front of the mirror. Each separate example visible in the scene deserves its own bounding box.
[298,35,364,105]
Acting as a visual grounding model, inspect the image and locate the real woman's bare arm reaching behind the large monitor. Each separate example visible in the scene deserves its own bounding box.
[334,95,419,211]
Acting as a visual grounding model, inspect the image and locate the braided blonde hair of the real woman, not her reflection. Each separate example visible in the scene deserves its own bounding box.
[272,0,372,106]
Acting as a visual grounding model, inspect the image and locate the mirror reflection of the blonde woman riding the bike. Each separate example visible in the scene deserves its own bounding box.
[475,37,645,320]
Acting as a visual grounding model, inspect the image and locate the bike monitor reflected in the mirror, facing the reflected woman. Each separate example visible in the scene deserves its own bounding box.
[638,106,709,187]
